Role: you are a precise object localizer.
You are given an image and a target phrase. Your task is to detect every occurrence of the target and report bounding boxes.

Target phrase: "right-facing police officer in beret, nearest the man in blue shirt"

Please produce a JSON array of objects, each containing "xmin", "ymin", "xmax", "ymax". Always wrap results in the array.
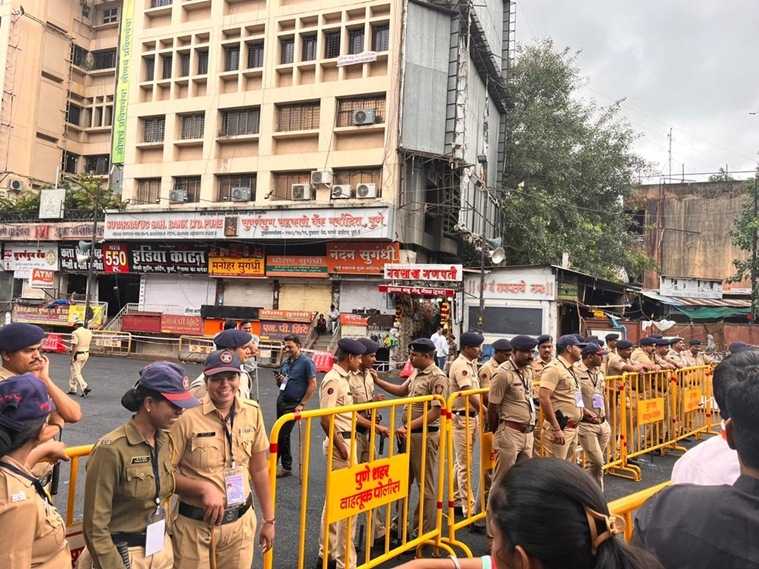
[{"xmin": 315, "ymin": 338, "xmax": 371, "ymax": 569}]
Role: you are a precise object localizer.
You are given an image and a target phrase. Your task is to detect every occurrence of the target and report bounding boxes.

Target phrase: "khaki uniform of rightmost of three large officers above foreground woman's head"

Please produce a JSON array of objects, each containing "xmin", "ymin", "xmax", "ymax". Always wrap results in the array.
[{"xmin": 575, "ymin": 362, "xmax": 611, "ymax": 491}]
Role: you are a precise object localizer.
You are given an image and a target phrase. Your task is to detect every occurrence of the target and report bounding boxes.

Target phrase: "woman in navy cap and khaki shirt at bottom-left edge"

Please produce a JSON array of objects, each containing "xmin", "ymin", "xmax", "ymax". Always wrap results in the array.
[{"xmin": 0, "ymin": 372, "xmax": 71, "ymax": 569}]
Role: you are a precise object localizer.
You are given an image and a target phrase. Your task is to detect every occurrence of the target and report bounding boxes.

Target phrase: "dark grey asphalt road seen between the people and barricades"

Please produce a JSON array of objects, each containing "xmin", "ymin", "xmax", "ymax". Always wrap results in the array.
[{"xmin": 44, "ymin": 354, "xmax": 704, "ymax": 569}]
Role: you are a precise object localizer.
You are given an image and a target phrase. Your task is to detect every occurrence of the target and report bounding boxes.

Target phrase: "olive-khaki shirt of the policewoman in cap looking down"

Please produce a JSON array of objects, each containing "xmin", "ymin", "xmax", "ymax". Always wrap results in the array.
[{"xmin": 83, "ymin": 418, "xmax": 174, "ymax": 567}]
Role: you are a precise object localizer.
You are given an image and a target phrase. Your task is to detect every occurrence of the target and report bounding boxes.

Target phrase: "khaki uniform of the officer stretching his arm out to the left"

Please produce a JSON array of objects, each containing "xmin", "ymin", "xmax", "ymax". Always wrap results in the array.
[{"xmin": 393, "ymin": 364, "xmax": 448, "ymax": 533}]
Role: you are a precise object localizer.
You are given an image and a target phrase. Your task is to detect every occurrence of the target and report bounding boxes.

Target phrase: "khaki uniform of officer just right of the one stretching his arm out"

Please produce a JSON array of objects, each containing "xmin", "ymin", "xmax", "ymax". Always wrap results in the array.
[{"xmin": 448, "ymin": 354, "xmax": 480, "ymax": 516}]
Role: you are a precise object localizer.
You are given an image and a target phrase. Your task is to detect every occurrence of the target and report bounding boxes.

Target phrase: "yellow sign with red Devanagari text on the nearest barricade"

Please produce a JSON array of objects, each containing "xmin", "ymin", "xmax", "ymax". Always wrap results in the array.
[{"xmin": 327, "ymin": 453, "xmax": 409, "ymax": 523}]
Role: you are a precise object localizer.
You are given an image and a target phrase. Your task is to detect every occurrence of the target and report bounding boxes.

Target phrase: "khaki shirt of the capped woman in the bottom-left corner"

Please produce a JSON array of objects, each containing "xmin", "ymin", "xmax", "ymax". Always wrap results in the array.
[{"xmin": 0, "ymin": 456, "xmax": 71, "ymax": 569}]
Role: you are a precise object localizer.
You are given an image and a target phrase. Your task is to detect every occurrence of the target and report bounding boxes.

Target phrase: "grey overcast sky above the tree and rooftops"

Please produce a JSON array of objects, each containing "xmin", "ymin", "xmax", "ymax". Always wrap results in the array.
[{"xmin": 517, "ymin": 0, "xmax": 759, "ymax": 182}]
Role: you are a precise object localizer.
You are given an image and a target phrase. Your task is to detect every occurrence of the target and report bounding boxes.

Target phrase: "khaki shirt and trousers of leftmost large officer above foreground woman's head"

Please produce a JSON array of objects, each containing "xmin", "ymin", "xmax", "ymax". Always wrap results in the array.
[{"xmin": 488, "ymin": 358, "xmax": 537, "ymax": 481}]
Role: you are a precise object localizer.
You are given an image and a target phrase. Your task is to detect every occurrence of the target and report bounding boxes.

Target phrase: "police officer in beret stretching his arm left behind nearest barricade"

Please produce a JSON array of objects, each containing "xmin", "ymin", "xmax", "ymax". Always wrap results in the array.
[{"xmin": 375, "ymin": 338, "xmax": 448, "ymax": 538}]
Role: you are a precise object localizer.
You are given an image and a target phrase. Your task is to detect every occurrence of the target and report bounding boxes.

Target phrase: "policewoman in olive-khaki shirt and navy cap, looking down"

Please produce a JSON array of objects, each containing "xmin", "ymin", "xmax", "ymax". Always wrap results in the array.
[{"xmin": 78, "ymin": 361, "xmax": 200, "ymax": 569}]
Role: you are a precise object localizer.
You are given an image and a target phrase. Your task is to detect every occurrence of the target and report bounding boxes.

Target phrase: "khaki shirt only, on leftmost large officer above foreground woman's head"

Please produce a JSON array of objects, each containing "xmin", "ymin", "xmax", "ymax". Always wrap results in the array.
[{"xmin": 488, "ymin": 359, "xmax": 535, "ymax": 425}]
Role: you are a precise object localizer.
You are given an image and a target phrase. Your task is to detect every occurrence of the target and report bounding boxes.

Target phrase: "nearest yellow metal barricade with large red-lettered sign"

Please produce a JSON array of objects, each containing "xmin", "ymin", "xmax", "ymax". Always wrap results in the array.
[{"xmin": 264, "ymin": 395, "xmax": 453, "ymax": 569}]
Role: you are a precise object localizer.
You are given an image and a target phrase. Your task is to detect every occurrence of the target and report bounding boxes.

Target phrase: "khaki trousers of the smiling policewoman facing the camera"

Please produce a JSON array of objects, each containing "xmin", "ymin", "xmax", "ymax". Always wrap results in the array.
[{"xmin": 172, "ymin": 508, "xmax": 257, "ymax": 569}]
